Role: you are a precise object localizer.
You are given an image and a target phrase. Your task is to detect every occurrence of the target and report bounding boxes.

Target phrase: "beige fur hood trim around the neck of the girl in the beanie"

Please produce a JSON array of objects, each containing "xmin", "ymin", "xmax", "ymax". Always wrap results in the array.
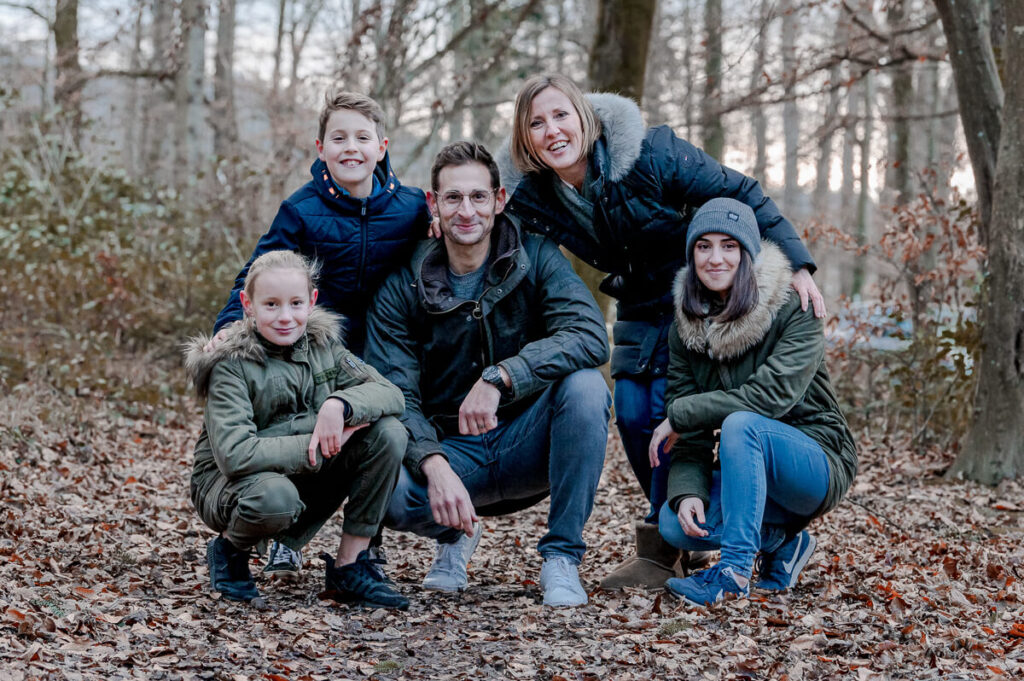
[{"xmin": 672, "ymin": 240, "xmax": 793, "ymax": 359}]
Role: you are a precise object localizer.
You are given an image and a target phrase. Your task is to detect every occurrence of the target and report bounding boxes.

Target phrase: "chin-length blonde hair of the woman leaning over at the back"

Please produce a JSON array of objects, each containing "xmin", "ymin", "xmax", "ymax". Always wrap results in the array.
[{"xmin": 509, "ymin": 74, "xmax": 601, "ymax": 173}]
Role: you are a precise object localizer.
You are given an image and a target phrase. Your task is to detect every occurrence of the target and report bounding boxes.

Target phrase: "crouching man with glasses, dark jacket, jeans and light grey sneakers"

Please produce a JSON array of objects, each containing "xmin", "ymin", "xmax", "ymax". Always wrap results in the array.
[{"xmin": 367, "ymin": 142, "xmax": 610, "ymax": 606}]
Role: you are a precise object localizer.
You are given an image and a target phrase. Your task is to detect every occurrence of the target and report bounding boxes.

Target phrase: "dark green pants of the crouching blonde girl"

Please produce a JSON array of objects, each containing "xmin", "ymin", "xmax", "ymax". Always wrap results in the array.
[{"xmin": 193, "ymin": 416, "xmax": 407, "ymax": 550}]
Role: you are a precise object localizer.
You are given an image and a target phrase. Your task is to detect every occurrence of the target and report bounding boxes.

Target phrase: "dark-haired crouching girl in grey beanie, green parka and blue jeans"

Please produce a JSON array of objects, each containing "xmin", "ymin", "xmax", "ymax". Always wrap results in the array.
[{"xmin": 648, "ymin": 199, "xmax": 857, "ymax": 605}]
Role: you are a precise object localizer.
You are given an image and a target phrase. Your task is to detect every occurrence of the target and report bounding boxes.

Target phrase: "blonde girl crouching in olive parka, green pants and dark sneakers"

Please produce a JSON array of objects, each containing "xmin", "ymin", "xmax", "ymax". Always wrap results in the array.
[{"xmin": 185, "ymin": 251, "xmax": 409, "ymax": 608}]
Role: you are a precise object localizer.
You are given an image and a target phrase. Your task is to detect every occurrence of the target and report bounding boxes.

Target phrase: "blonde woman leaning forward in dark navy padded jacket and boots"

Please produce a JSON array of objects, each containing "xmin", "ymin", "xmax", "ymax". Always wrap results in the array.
[{"xmin": 501, "ymin": 74, "xmax": 824, "ymax": 589}]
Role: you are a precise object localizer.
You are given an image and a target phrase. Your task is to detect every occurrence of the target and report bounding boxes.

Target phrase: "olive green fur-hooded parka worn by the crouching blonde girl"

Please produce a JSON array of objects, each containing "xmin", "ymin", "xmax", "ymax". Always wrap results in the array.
[{"xmin": 185, "ymin": 307, "xmax": 404, "ymax": 501}]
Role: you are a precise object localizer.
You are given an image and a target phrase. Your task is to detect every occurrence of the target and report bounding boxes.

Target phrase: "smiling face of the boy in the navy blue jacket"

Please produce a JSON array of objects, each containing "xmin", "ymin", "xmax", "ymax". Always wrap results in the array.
[{"xmin": 316, "ymin": 109, "xmax": 387, "ymax": 199}]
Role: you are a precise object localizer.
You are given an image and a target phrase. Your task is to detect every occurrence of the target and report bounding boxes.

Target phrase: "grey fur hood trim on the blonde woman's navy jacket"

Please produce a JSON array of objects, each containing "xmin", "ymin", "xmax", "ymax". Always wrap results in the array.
[{"xmin": 496, "ymin": 92, "xmax": 647, "ymax": 195}]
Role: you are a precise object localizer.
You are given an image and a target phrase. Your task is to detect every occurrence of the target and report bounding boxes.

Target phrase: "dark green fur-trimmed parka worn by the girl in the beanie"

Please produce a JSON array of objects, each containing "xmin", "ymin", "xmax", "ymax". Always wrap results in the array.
[{"xmin": 665, "ymin": 241, "xmax": 857, "ymax": 515}]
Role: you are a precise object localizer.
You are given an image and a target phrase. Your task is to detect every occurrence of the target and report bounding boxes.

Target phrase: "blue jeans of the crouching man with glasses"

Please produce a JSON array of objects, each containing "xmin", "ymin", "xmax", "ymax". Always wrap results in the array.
[{"xmin": 384, "ymin": 369, "xmax": 611, "ymax": 563}]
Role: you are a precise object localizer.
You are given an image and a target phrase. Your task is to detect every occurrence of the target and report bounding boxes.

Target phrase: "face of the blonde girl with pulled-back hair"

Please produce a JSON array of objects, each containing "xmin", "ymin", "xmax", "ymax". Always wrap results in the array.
[{"xmin": 240, "ymin": 268, "xmax": 316, "ymax": 345}]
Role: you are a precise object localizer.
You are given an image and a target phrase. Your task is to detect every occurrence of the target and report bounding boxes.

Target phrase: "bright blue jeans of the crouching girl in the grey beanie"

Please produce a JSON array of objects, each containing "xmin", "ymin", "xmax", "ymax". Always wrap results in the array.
[{"xmin": 658, "ymin": 412, "xmax": 828, "ymax": 577}]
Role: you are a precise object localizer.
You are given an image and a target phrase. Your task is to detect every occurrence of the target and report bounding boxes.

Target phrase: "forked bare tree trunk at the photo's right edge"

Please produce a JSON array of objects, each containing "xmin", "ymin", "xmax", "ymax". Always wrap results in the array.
[{"xmin": 935, "ymin": 0, "xmax": 1024, "ymax": 484}]
